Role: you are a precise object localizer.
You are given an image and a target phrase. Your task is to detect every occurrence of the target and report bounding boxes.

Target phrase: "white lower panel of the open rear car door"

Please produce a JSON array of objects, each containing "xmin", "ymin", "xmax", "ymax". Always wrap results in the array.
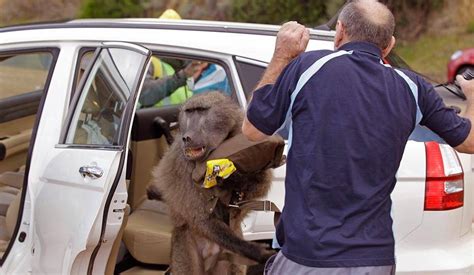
[{"xmin": 32, "ymin": 148, "xmax": 122, "ymax": 274}]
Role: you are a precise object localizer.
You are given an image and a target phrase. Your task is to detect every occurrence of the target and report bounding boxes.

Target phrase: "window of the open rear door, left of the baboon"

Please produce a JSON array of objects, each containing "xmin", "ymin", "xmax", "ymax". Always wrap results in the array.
[{"xmin": 64, "ymin": 48, "xmax": 145, "ymax": 146}]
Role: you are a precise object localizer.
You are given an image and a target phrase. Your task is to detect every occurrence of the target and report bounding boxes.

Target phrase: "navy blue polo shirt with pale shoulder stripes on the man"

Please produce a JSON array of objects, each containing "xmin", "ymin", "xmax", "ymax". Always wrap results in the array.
[{"xmin": 247, "ymin": 42, "xmax": 471, "ymax": 267}]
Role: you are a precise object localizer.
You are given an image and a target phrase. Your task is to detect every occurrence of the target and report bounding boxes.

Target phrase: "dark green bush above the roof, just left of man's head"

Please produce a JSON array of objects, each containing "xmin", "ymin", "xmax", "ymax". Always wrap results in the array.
[{"xmin": 232, "ymin": 0, "xmax": 329, "ymax": 26}]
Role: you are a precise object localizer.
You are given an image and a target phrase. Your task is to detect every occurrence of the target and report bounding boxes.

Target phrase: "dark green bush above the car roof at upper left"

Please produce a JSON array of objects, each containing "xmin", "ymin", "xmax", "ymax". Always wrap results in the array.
[{"xmin": 80, "ymin": 0, "xmax": 144, "ymax": 18}]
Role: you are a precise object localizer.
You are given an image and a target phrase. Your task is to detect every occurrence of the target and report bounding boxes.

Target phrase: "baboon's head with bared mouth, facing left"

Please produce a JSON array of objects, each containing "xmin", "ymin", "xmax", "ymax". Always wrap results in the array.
[{"xmin": 179, "ymin": 92, "xmax": 240, "ymax": 161}]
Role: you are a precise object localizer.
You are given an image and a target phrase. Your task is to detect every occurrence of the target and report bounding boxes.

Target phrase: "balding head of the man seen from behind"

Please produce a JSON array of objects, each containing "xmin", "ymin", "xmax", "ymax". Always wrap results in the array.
[{"xmin": 339, "ymin": 0, "xmax": 395, "ymax": 50}]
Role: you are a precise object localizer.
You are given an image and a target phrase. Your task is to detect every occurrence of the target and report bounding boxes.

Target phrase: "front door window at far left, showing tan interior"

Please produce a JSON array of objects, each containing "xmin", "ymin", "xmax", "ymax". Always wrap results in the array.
[{"xmin": 0, "ymin": 50, "xmax": 55, "ymax": 164}]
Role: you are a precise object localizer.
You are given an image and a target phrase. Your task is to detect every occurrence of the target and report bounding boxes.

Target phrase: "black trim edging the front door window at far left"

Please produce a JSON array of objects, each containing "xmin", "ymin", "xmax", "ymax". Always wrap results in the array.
[{"xmin": 0, "ymin": 46, "xmax": 60, "ymax": 266}]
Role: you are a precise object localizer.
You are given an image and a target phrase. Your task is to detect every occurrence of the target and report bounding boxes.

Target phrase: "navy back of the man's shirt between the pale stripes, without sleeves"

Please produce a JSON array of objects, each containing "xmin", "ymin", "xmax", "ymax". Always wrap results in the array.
[{"xmin": 274, "ymin": 43, "xmax": 416, "ymax": 267}]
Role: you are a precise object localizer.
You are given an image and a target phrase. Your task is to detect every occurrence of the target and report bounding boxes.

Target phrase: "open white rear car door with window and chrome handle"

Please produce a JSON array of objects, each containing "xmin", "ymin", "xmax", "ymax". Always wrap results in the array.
[{"xmin": 4, "ymin": 42, "xmax": 151, "ymax": 274}]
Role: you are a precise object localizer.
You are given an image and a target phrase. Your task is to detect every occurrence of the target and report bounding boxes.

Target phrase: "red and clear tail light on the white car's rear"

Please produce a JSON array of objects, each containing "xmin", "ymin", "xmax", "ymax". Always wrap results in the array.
[{"xmin": 425, "ymin": 142, "xmax": 464, "ymax": 211}]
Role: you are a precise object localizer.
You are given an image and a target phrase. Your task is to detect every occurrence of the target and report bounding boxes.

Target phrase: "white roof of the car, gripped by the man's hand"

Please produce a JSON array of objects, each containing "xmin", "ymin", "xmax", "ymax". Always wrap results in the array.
[{"xmin": 0, "ymin": 18, "xmax": 334, "ymax": 62}]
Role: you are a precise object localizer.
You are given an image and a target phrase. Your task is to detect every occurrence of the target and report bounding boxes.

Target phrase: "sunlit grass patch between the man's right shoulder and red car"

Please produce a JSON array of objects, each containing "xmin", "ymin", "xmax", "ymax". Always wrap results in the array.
[{"xmin": 396, "ymin": 32, "xmax": 474, "ymax": 82}]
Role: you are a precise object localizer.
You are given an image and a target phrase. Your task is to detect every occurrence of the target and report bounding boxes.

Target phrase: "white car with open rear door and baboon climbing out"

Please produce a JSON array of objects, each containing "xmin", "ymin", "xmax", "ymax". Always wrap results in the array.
[{"xmin": 0, "ymin": 19, "xmax": 474, "ymax": 274}]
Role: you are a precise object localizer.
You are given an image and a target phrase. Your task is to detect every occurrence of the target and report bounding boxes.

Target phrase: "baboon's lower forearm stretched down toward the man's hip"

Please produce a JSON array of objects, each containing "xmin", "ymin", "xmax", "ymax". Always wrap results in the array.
[{"xmin": 192, "ymin": 217, "xmax": 273, "ymax": 263}]
